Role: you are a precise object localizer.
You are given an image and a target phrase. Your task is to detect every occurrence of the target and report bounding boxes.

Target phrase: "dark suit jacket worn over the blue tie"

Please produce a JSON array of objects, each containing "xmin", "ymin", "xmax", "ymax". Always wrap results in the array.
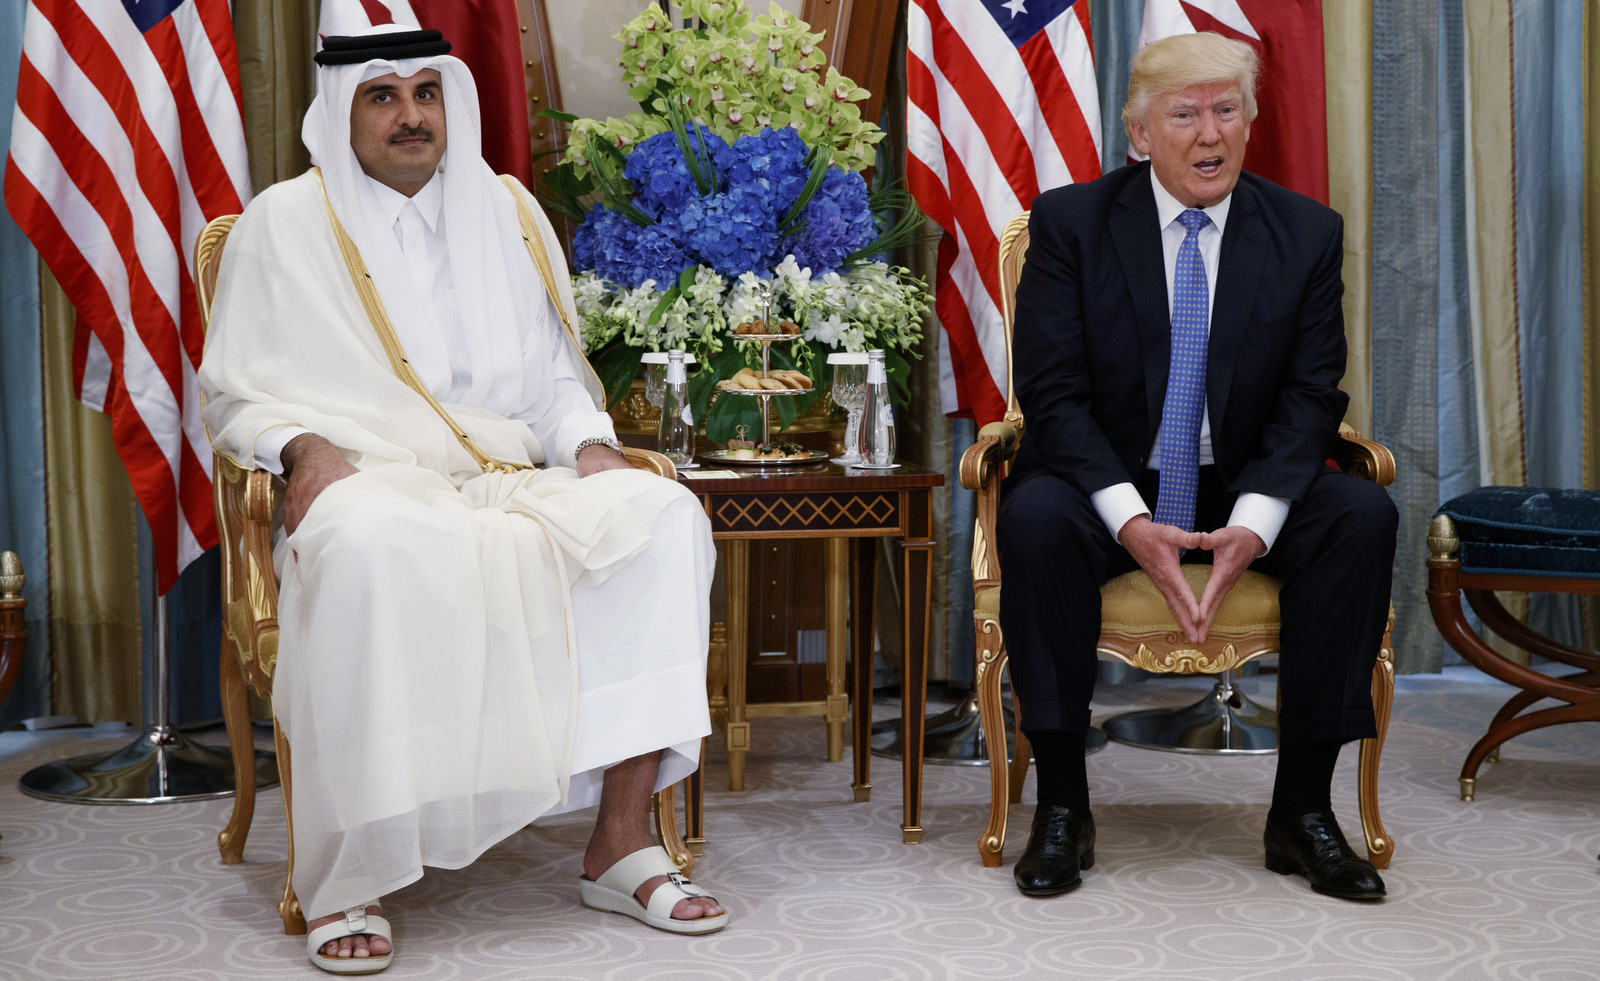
[{"xmin": 1011, "ymin": 163, "xmax": 1349, "ymax": 501}]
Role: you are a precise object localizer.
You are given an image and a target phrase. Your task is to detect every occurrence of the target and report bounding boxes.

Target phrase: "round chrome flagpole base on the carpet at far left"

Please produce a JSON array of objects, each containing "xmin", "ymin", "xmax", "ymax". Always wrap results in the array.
[{"xmin": 18, "ymin": 725, "xmax": 278, "ymax": 803}]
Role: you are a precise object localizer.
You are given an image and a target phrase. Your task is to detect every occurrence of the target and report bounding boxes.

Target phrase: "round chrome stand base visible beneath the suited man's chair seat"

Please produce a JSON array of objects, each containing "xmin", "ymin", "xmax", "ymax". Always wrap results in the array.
[{"xmin": 1101, "ymin": 677, "xmax": 1278, "ymax": 755}]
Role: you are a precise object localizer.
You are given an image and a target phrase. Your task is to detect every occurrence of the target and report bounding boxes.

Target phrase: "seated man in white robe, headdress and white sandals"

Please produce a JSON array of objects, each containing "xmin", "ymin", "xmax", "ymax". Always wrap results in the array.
[{"xmin": 198, "ymin": 26, "xmax": 726, "ymax": 971}]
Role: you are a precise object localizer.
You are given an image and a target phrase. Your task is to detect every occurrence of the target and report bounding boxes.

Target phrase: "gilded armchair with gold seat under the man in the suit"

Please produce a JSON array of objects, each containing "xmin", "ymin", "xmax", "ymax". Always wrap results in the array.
[{"xmin": 960, "ymin": 211, "xmax": 1395, "ymax": 869}]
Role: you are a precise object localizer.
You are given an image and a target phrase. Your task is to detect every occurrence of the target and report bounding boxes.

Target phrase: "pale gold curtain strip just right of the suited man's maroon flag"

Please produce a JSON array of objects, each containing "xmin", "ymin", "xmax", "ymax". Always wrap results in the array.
[{"xmin": 1322, "ymin": 3, "xmax": 1373, "ymax": 434}]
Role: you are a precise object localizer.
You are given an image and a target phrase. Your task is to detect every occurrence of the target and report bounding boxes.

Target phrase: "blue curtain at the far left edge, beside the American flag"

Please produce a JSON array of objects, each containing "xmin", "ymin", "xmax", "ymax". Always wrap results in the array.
[{"xmin": 0, "ymin": 3, "xmax": 50, "ymax": 728}]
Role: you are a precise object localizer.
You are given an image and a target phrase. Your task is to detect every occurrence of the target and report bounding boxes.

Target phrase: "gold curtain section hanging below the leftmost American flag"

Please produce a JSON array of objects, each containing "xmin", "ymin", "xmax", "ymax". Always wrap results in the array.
[{"xmin": 38, "ymin": 262, "xmax": 141, "ymax": 723}]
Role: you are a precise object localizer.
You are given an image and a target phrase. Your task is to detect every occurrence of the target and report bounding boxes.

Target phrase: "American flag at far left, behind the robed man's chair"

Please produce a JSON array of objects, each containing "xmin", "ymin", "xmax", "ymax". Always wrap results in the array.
[{"xmin": 5, "ymin": 0, "xmax": 250, "ymax": 592}]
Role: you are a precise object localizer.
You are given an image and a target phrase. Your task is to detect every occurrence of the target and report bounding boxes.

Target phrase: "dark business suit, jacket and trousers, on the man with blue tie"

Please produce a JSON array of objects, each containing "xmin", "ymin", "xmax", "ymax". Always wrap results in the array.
[{"xmin": 997, "ymin": 163, "xmax": 1397, "ymax": 746}]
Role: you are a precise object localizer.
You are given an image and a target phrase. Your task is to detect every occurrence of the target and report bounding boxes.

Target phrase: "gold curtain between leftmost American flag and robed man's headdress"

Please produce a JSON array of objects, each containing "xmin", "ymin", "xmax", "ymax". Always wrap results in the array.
[{"xmin": 234, "ymin": 0, "xmax": 322, "ymax": 192}]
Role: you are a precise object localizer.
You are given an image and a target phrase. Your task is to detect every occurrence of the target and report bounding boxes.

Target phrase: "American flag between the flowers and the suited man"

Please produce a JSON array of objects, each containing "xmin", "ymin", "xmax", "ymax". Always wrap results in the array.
[{"xmin": 906, "ymin": 0, "xmax": 1101, "ymax": 426}]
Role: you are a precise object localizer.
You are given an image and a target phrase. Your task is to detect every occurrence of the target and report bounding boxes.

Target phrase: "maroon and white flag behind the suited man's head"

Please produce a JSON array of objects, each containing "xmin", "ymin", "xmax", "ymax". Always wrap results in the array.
[{"xmin": 1139, "ymin": 0, "xmax": 1328, "ymax": 205}]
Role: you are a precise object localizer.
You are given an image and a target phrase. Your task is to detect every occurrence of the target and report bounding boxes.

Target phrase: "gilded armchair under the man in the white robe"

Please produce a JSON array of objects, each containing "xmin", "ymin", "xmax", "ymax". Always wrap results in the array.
[{"xmin": 194, "ymin": 214, "xmax": 694, "ymax": 935}]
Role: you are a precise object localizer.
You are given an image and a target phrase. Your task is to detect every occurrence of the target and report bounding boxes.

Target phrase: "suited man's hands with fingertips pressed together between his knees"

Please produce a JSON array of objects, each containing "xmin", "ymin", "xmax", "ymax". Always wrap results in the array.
[{"xmin": 1117, "ymin": 514, "xmax": 1266, "ymax": 643}]
